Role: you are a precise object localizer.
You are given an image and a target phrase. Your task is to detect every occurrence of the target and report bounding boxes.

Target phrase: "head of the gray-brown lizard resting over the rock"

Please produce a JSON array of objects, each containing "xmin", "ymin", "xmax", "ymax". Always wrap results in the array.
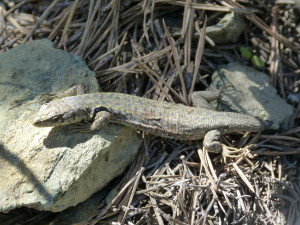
[{"xmin": 33, "ymin": 100, "xmax": 89, "ymax": 127}]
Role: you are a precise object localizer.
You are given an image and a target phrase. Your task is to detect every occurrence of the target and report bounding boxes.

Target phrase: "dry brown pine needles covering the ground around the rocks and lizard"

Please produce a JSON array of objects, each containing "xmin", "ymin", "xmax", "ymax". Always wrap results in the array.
[{"xmin": 0, "ymin": 0, "xmax": 300, "ymax": 225}]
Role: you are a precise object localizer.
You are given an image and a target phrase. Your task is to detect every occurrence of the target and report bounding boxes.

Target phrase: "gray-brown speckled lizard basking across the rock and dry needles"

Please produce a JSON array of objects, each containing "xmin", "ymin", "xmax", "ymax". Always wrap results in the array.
[{"xmin": 33, "ymin": 92, "xmax": 270, "ymax": 152}]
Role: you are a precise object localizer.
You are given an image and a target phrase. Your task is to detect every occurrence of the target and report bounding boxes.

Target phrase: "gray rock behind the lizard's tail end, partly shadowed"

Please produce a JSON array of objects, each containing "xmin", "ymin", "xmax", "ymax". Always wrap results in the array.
[{"xmin": 212, "ymin": 63, "xmax": 294, "ymax": 129}]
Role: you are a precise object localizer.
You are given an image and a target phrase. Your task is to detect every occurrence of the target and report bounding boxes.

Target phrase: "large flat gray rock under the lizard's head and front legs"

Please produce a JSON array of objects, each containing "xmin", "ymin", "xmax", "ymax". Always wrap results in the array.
[{"xmin": 0, "ymin": 40, "xmax": 141, "ymax": 212}]
